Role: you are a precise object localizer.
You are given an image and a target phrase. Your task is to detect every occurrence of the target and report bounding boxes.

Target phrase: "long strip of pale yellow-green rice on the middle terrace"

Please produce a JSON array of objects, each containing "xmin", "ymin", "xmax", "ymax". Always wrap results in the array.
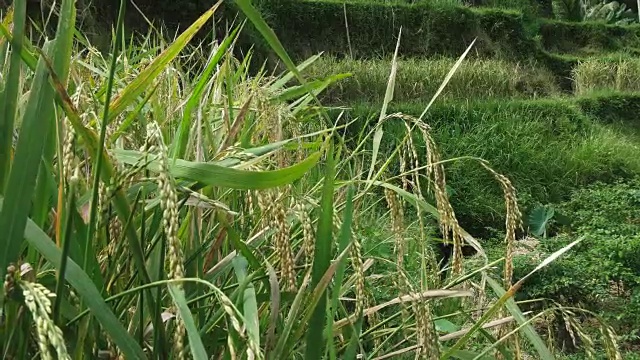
[{"xmin": 305, "ymin": 57, "xmax": 559, "ymax": 104}]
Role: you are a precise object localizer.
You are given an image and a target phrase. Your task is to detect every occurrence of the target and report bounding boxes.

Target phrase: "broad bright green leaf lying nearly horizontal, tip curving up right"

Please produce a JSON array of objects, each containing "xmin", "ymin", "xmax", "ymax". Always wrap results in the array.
[{"xmin": 113, "ymin": 150, "xmax": 320, "ymax": 189}]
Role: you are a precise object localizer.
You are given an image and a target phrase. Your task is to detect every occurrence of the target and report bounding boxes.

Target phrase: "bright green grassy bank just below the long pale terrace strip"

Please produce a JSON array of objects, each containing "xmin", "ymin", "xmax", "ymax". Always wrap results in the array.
[{"xmin": 336, "ymin": 97, "xmax": 640, "ymax": 234}]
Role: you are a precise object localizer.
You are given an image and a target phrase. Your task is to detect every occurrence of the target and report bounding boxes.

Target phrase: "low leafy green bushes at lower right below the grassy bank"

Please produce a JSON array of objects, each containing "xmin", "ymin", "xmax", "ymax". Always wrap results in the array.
[{"xmin": 514, "ymin": 177, "xmax": 640, "ymax": 347}]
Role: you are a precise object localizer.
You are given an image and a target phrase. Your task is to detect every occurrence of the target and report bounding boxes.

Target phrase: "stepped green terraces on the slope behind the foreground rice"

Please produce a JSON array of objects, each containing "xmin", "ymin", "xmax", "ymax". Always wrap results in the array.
[{"xmin": 236, "ymin": 0, "xmax": 640, "ymax": 231}]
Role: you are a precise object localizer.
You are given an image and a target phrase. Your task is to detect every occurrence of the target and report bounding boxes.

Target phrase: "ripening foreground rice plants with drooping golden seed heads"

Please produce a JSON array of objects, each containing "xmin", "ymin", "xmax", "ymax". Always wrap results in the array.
[{"xmin": 0, "ymin": 0, "xmax": 610, "ymax": 359}]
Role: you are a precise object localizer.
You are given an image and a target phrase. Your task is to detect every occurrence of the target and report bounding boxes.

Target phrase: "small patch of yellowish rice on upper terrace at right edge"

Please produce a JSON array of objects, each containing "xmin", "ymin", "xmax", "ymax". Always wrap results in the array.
[{"xmin": 573, "ymin": 57, "xmax": 640, "ymax": 95}]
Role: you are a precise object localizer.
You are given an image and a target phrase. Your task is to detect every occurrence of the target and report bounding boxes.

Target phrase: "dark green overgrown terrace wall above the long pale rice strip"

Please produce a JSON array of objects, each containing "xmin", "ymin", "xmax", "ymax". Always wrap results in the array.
[{"xmin": 248, "ymin": 0, "xmax": 535, "ymax": 59}]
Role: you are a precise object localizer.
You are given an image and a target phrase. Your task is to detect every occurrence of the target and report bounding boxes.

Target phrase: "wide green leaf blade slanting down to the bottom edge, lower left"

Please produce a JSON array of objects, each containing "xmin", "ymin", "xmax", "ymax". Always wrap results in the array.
[{"xmin": 0, "ymin": 198, "xmax": 147, "ymax": 359}]
